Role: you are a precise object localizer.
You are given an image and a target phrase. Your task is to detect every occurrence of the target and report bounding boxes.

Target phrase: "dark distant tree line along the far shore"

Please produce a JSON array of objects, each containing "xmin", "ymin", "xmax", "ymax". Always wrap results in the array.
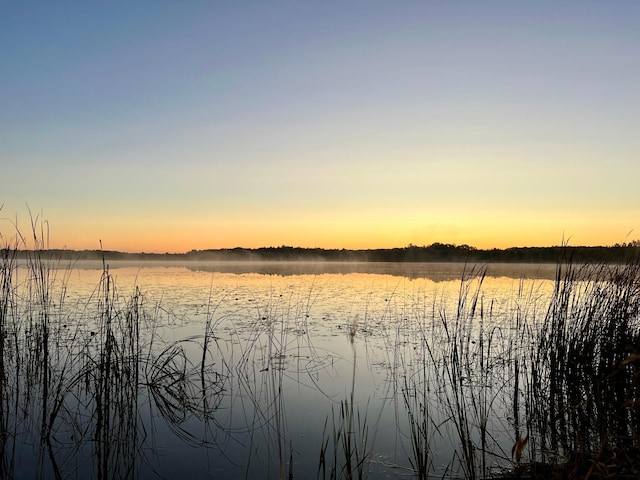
[{"xmin": 5, "ymin": 240, "xmax": 640, "ymax": 263}]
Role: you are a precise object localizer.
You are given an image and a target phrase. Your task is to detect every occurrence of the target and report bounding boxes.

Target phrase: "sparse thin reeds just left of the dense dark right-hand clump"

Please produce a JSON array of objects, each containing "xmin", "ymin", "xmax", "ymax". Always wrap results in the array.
[{"xmin": 433, "ymin": 267, "xmax": 516, "ymax": 478}]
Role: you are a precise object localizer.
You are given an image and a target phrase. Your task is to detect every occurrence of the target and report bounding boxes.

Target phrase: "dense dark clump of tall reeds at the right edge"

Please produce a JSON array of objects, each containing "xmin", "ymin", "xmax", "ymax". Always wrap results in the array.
[{"xmin": 527, "ymin": 258, "xmax": 640, "ymax": 478}]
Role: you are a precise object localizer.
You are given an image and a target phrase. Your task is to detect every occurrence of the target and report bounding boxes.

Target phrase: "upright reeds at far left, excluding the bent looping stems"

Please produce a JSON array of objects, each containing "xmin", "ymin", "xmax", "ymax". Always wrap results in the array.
[{"xmin": 2, "ymin": 249, "xmax": 148, "ymax": 478}]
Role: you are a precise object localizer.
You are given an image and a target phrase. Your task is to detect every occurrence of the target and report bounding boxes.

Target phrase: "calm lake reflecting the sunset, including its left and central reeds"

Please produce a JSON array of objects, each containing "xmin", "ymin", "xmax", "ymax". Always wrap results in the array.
[{"xmin": 0, "ymin": 262, "xmax": 620, "ymax": 479}]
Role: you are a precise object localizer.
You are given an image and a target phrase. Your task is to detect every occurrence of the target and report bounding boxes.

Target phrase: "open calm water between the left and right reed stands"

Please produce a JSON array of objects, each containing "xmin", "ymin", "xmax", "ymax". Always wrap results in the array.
[{"xmin": 12, "ymin": 262, "xmax": 555, "ymax": 479}]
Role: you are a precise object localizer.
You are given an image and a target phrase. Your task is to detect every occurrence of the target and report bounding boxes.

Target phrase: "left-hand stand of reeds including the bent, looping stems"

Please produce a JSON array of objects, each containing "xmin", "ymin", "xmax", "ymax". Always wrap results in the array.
[{"xmin": 0, "ymin": 219, "xmax": 226, "ymax": 479}]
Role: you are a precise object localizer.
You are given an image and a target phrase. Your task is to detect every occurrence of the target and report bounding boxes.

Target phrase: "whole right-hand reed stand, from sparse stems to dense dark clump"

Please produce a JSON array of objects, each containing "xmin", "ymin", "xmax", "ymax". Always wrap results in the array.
[{"xmin": 396, "ymin": 253, "xmax": 640, "ymax": 478}]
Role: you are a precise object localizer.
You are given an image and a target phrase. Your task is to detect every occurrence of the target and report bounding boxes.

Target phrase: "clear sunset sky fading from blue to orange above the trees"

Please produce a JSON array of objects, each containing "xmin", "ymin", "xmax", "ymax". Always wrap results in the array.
[{"xmin": 0, "ymin": 0, "xmax": 640, "ymax": 253}]
